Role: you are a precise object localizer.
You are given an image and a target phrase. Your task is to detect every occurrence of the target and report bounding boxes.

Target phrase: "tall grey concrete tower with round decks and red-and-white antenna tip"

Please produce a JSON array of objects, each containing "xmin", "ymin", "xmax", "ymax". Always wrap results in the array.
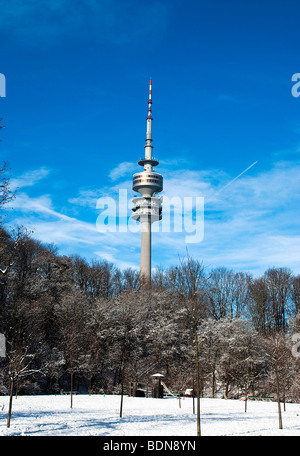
[{"xmin": 132, "ymin": 79, "xmax": 163, "ymax": 285}]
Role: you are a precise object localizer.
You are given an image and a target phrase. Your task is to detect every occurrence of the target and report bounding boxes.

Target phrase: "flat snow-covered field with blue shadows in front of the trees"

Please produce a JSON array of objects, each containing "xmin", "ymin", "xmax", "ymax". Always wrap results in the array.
[{"xmin": 0, "ymin": 395, "xmax": 300, "ymax": 436}]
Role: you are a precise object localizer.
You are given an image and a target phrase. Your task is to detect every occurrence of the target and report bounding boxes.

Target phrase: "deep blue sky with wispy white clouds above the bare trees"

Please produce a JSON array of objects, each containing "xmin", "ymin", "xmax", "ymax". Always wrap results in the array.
[{"xmin": 0, "ymin": 0, "xmax": 300, "ymax": 275}]
